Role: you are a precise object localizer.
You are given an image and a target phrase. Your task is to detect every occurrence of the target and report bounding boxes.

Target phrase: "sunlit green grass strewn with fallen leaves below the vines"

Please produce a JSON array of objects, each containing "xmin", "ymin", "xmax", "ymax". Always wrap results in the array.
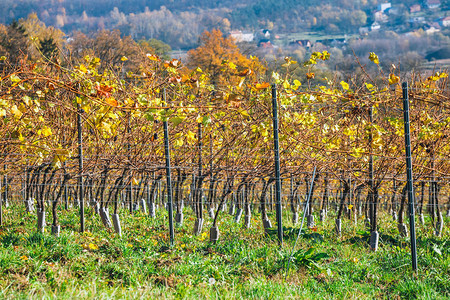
[{"xmin": 0, "ymin": 207, "xmax": 450, "ymax": 299}]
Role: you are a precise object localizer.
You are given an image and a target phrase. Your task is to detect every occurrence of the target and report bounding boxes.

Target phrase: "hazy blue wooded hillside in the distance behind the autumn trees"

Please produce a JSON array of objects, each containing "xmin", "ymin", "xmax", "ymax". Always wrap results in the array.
[{"xmin": 0, "ymin": 0, "xmax": 450, "ymax": 49}]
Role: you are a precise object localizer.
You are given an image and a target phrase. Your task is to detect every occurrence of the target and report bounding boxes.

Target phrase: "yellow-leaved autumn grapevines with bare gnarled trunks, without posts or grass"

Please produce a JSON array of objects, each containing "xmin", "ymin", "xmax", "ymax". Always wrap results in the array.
[{"xmin": 0, "ymin": 51, "xmax": 450, "ymax": 247}]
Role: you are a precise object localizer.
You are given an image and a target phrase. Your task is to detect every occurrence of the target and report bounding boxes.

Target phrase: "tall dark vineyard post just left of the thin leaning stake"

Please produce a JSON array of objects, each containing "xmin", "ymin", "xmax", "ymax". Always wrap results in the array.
[{"xmin": 272, "ymin": 84, "xmax": 283, "ymax": 247}]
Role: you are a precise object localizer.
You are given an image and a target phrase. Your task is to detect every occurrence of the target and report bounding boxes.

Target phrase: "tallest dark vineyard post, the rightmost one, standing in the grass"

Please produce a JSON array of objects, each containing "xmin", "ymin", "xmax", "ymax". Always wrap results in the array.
[{"xmin": 402, "ymin": 82, "xmax": 417, "ymax": 271}]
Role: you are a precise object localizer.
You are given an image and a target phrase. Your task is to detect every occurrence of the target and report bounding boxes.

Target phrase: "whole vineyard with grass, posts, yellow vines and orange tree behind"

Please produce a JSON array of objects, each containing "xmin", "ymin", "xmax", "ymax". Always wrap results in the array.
[{"xmin": 0, "ymin": 27, "xmax": 450, "ymax": 299}]
